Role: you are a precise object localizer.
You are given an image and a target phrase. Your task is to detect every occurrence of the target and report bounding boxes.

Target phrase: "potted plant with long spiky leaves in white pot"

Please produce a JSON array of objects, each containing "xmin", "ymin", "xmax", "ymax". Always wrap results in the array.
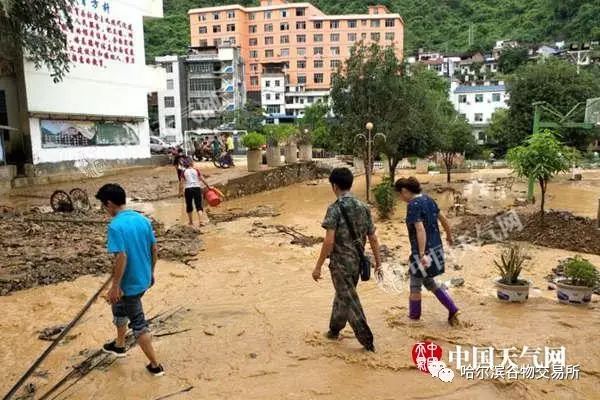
[{"xmin": 494, "ymin": 245, "xmax": 530, "ymax": 302}]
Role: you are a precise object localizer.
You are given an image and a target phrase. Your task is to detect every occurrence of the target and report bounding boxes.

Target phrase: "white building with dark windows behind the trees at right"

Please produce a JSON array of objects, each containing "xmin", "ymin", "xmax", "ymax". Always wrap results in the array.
[{"xmin": 450, "ymin": 81, "xmax": 508, "ymax": 144}]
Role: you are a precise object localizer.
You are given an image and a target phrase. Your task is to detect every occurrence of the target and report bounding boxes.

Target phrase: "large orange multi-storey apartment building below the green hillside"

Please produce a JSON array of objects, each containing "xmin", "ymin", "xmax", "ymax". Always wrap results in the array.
[{"xmin": 188, "ymin": 0, "xmax": 404, "ymax": 117}]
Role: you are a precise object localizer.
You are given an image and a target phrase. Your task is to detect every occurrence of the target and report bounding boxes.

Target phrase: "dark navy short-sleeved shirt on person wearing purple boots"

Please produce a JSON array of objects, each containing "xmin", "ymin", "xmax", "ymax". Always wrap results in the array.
[{"xmin": 406, "ymin": 194, "xmax": 442, "ymax": 257}]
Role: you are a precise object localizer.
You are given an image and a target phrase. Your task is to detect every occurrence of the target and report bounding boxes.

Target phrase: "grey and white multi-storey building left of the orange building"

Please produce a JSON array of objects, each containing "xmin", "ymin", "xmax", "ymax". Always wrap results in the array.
[{"xmin": 156, "ymin": 44, "xmax": 246, "ymax": 142}]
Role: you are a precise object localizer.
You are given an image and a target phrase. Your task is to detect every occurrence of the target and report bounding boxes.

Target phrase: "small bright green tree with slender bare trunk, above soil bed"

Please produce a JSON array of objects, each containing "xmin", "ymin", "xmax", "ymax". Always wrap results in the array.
[{"xmin": 507, "ymin": 130, "xmax": 577, "ymax": 222}]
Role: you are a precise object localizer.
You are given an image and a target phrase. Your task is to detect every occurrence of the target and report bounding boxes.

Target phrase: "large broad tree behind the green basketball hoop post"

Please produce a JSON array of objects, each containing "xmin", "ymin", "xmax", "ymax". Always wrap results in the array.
[{"xmin": 498, "ymin": 60, "xmax": 600, "ymax": 149}]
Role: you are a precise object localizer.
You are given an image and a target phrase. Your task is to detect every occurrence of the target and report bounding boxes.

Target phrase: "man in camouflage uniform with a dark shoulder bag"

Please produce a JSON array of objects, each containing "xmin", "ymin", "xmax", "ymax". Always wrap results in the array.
[{"xmin": 312, "ymin": 168, "xmax": 381, "ymax": 351}]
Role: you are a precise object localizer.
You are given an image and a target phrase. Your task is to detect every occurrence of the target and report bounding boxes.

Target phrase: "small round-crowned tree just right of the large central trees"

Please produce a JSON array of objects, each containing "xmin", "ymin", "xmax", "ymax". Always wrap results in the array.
[{"xmin": 439, "ymin": 114, "xmax": 475, "ymax": 183}]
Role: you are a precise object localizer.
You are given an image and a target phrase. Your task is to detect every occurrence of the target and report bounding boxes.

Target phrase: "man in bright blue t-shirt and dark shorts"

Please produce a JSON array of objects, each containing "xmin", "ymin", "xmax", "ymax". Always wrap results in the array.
[{"xmin": 96, "ymin": 184, "xmax": 164, "ymax": 376}]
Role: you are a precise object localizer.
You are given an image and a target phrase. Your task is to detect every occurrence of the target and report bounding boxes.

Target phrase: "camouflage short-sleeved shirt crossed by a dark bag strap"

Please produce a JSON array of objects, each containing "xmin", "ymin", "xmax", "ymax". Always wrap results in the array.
[{"xmin": 321, "ymin": 193, "xmax": 375, "ymax": 272}]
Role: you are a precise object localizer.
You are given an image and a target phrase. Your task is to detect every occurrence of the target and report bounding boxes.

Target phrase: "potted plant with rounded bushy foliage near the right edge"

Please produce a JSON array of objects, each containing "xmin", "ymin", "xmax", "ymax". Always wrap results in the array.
[{"xmin": 556, "ymin": 256, "xmax": 599, "ymax": 304}]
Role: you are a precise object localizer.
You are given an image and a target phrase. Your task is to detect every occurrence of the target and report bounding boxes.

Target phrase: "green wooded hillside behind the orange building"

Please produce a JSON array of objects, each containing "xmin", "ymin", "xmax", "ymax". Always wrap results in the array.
[{"xmin": 145, "ymin": 0, "xmax": 600, "ymax": 60}]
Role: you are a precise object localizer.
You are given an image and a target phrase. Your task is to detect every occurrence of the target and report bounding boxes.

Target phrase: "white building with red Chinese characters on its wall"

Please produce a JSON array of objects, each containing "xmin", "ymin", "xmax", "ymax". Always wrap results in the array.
[{"xmin": 0, "ymin": 0, "xmax": 164, "ymax": 188}]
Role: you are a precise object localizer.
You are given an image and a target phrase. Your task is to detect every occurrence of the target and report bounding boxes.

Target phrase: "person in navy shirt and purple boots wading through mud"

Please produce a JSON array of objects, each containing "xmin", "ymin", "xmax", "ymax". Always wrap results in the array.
[{"xmin": 395, "ymin": 177, "xmax": 458, "ymax": 326}]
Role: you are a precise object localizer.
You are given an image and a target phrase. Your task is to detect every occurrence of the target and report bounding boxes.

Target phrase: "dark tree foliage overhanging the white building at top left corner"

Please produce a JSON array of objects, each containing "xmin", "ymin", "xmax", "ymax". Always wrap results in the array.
[{"xmin": 0, "ymin": 0, "xmax": 73, "ymax": 82}]
